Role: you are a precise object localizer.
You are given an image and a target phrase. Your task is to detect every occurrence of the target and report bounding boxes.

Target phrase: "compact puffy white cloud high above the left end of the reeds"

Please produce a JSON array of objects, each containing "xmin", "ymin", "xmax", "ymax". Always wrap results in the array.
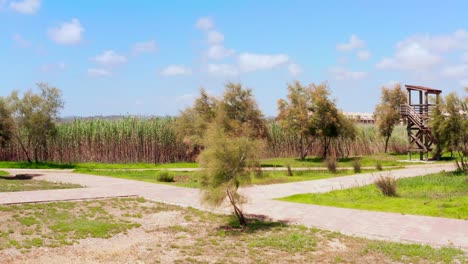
[{"xmin": 48, "ymin": 18, "xmax": 84, "ymax": 44}]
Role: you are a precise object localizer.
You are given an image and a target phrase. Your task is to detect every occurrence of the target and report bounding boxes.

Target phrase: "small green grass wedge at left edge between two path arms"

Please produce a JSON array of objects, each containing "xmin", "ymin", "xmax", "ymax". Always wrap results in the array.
[{"xmin": 0, "ymin": 171, "xmax": 83, "ymax": 192}]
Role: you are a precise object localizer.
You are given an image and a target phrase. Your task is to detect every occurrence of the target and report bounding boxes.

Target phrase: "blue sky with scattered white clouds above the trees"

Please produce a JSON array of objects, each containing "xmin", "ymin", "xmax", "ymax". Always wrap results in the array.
[{"xmin": 0, "ymin": 0, "xmax": 468, "ymax": 116}]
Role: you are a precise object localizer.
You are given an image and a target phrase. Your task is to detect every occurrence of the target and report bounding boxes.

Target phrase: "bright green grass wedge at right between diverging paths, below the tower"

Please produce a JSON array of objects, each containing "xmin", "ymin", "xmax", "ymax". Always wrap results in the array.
[{"xmin": 280, "ymin": 173, "xmax": 468, "ymax": 219}]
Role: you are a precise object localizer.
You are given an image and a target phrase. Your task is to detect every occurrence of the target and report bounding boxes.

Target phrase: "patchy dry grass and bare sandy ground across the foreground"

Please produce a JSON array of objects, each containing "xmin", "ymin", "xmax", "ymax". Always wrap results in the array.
[{"xmin": 0, "ymin": 198, "xmax": 466, "ymax": 263}]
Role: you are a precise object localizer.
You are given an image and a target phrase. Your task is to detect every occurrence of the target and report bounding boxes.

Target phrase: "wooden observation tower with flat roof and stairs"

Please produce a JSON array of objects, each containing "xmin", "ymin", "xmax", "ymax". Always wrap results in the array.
[{"xmin": 400, "ymin": 85, "xmax": 442, "ymax": 160}]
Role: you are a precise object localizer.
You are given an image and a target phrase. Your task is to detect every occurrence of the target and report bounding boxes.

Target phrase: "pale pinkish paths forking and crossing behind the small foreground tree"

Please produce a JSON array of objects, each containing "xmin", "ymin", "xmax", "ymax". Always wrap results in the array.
[{"xmin": 0, "ymin": 164, "xmax": 468, "ymax": 250}]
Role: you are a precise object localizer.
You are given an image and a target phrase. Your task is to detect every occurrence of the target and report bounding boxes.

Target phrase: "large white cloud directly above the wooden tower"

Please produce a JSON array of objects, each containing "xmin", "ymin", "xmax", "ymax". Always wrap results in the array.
[{"xmin": 376, "ymin": 43, "xmax": 442, "ymax": 70}]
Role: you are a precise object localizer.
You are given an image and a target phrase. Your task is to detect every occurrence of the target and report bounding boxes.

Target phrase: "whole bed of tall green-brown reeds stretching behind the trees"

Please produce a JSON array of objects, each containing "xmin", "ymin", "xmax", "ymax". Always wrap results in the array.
[{"xmin": 0, "ymin": 117, "xmax": 407, "ymax": 163}]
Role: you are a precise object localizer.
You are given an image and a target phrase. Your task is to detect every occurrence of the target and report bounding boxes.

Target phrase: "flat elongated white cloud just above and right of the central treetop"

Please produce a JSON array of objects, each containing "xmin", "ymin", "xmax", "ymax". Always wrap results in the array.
[{"xmin": 239, "ymin": 53, "xmax": 289, "ymax": 72}]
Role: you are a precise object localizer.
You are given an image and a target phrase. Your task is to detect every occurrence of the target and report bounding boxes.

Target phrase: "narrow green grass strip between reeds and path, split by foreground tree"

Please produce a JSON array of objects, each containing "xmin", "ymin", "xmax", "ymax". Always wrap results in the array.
[{"xmin": 75, "ymin": 169, "xmax": 376, "ymax": 188}]
